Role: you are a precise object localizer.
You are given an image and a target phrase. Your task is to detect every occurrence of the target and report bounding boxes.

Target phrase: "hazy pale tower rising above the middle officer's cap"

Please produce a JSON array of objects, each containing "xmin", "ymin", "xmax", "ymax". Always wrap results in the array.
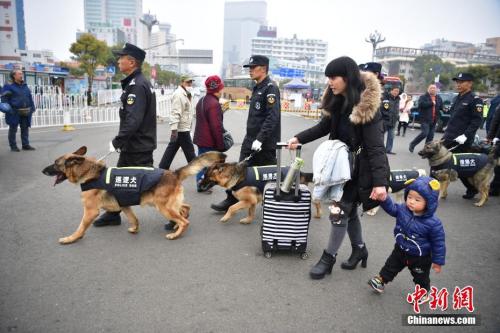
[{"xmin": 222, "ymin": 1, "xmax": 267, "ymax": 75}]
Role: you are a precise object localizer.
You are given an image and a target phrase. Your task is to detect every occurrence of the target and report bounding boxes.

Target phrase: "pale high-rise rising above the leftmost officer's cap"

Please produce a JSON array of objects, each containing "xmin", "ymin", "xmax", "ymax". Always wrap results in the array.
[{"xmin": 84, "ymin": 0, "xmax": 142, "ymax": 44}]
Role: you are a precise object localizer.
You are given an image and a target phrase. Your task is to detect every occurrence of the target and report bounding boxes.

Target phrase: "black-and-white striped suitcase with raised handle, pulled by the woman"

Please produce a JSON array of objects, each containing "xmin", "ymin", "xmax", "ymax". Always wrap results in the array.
[{"xmin": 261, "ymin": 143, "xmax": 311, "ymax": 259}]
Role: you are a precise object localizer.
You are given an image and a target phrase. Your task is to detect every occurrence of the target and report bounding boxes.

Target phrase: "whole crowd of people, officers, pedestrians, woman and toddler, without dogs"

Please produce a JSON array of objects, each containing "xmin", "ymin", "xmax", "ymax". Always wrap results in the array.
[{"xmin": 2, "ymin": 43, "xmax": 500, "ymax": 292}]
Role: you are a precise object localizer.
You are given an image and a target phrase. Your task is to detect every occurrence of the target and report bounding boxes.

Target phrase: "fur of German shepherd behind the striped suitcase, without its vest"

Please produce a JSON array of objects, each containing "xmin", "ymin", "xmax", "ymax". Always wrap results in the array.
[{"xmin": 200, "ymin": 162, "xmax": 321, "ymax": 224}]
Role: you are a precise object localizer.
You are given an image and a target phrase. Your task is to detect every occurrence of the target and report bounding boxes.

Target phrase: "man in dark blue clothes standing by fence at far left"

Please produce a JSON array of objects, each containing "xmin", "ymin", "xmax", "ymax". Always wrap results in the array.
[{"xmin": 1, "ymin": 69, "xmax": 36, "ymax": 152}]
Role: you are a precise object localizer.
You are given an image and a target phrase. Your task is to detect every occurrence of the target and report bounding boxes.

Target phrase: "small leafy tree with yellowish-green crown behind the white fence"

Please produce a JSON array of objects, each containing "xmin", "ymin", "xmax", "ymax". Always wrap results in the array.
[{"xmin": 69, "ymin": 34, "xmax": 109, "ymax": 105}]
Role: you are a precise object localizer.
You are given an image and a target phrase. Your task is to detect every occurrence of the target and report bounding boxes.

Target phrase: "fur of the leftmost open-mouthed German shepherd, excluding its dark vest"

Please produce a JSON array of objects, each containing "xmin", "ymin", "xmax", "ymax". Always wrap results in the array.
[{"xmin": 42, "ymin": 146, "xmax": 226, "ymax": 244}]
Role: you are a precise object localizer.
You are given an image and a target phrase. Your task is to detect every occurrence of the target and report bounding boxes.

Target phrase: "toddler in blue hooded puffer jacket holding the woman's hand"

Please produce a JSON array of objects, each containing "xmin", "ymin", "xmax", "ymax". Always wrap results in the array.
[{"xmin": 368, "ymin": 177, "xmax": 446, "ymax": 295}]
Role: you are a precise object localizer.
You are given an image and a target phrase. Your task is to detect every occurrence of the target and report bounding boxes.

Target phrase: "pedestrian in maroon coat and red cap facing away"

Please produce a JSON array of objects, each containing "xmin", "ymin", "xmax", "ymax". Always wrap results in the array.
[{"xmin": 193, "ymin": 75, "xmax": 224, "ymax": 189}]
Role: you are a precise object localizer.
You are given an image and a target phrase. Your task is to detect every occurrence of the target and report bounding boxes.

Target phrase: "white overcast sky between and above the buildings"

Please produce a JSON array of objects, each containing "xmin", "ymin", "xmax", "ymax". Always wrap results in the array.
[{"xmin": 24, "ymin": 0, "xmax": 500, "ymax": 74}]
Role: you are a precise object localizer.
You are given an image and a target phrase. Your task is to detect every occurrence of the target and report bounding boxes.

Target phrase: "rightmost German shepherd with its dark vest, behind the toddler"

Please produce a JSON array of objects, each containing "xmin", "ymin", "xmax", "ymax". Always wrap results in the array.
[{"xmin": 418, "ymin": 140, "xmax": 500, "ymax": 207}]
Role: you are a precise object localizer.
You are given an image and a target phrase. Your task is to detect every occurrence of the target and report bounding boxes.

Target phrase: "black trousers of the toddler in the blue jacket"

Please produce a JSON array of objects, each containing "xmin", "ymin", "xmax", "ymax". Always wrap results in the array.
[{"xmin": 379, "ymin": 244, "xmax": 432, "ymax": 291}]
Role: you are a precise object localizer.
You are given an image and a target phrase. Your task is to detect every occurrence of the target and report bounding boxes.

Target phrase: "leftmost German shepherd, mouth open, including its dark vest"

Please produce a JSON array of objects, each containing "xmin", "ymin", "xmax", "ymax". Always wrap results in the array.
[{"xmin": 42, "ymin": 146, "xmax": 226, "ymax": 244}]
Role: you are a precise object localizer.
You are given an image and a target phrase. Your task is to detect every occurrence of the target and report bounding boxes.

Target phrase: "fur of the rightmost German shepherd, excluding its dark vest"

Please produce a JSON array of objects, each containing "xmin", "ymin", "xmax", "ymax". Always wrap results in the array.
[{"xmin": 418, "ymin": 141, "xmax": 500, "ymax": 207}]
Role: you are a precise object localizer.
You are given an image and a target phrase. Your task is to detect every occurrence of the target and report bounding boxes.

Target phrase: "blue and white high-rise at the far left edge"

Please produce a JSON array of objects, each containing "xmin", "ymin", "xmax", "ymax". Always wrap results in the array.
[{"xmin": 0, "ymin": 0, "xmax": 26, "ymax": 64}]
